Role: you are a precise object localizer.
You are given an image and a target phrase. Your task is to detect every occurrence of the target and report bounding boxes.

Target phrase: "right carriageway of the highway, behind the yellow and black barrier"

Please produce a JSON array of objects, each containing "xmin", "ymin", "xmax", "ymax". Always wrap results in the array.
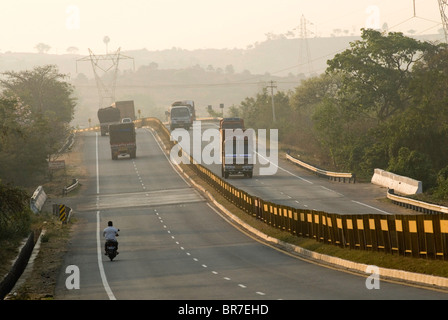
[{"xmin": 184, "ymin": 122, "xmax": 416, "ymax": 214}]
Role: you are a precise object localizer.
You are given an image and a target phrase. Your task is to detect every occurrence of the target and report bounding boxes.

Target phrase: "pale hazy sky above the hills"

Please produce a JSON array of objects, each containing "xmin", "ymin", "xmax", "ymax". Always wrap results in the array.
[{"xmin": 0, "ymin": 0, "xmax": 442, "ymax": 54}]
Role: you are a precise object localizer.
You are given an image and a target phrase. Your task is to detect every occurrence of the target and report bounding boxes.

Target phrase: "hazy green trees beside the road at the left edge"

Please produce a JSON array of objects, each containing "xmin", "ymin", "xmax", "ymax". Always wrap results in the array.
[{"xmin": 0, "ymin": 66, "xmax": 75, "ymax": 240}]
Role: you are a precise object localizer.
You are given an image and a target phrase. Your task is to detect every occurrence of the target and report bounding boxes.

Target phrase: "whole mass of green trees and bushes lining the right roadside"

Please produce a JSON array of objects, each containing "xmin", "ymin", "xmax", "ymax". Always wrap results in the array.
[{"xmin": 232, "ymin": 30, "xmax": 448, "ymax": 198}]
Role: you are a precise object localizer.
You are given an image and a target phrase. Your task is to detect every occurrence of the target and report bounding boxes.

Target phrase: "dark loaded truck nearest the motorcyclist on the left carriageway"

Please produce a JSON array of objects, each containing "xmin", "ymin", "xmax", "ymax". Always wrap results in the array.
[{"xmin": 109, "ymin": 122, "xmax": 137, "ymax": 160}]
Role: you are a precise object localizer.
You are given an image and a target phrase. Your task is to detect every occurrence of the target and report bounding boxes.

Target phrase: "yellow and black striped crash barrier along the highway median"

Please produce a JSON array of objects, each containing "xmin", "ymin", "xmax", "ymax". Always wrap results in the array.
[{"xmin": 143, "ymin": 118, "xmax": 448, "ymax": 260}]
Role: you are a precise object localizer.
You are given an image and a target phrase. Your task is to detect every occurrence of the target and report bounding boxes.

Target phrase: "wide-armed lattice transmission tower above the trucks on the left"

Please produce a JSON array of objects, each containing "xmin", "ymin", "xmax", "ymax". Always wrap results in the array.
[{"xmin": 76, "ymin": 48, "xmax": 135, "ymax": 108}]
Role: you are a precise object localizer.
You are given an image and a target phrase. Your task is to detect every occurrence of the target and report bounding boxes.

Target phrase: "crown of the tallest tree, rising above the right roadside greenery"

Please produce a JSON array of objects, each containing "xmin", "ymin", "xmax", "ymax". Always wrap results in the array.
[{"xmin": 327, "ymin": 29, "xmax": 432, "ymax": 121}]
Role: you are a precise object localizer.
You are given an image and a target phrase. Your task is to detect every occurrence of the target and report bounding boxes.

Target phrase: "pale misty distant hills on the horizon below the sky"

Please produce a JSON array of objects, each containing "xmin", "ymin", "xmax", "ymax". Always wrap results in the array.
[{"xmin": 0, "ymin": 35, "xmax": 440, "ymax": 126}]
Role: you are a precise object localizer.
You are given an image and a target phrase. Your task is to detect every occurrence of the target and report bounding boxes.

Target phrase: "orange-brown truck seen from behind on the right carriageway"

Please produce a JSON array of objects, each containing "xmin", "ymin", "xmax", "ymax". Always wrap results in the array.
[{"xmin": 219, "ymin": 118, "xmax": 254, "ymax": 179}]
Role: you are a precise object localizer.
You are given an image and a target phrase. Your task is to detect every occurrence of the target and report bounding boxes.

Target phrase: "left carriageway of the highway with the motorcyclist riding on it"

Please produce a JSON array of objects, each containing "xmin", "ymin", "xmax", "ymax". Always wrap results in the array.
[{"xmin": 55, "ymin": 128, "xmax": 448, "ymax": 300}]
